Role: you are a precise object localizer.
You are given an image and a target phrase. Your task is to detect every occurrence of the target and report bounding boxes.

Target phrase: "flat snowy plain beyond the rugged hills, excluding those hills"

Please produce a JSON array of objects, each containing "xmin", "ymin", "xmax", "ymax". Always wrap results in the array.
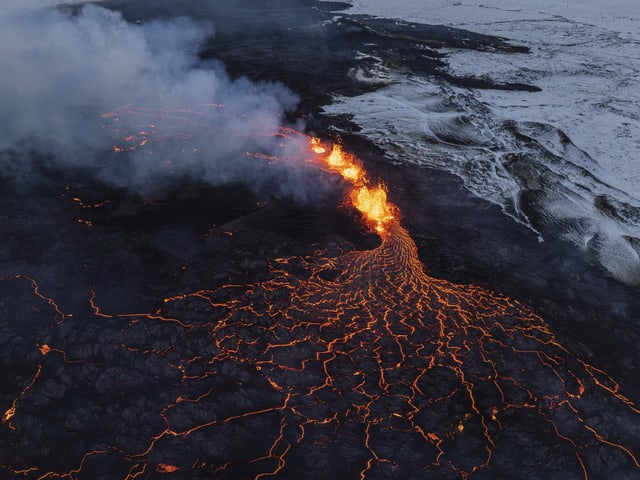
[{"xmin": 344, "ymin": 0, "xmax": 640, "ymax": 197}]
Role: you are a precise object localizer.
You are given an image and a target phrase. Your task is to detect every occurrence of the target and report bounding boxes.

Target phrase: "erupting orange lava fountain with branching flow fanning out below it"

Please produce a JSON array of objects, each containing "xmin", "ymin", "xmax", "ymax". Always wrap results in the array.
[{"xmin": 0, "ymin": 113, "xmax": 640, "ymax": 480}]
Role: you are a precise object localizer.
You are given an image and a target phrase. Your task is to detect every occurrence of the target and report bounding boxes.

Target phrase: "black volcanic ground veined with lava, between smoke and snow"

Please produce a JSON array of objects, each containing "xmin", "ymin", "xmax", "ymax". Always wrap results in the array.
[{"xmin": 0, "ymin": 1, "xmax": 640, "ymax": 479}]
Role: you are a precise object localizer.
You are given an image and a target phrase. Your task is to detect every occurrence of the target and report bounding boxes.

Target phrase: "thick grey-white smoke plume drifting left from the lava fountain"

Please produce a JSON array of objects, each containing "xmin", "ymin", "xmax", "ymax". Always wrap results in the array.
[{"xmin": 0, "ymin": 2, "xmax": 316, "ymax": 198}]
